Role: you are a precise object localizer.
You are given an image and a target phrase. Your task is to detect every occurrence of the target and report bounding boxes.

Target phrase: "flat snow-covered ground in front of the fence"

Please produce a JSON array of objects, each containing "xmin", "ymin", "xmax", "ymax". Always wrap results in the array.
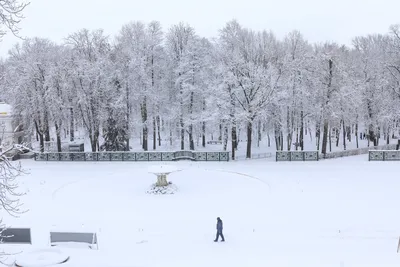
[{"xmin": 0, "ymin": 155, "xmax": 400, "ymax": 267}]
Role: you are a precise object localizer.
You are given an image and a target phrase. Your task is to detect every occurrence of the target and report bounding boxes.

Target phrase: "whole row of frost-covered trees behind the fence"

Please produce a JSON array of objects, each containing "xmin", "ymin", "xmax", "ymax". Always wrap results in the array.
[{"xmin": 1, "ymin": 21, "xmax": 400, "ymax": 158}]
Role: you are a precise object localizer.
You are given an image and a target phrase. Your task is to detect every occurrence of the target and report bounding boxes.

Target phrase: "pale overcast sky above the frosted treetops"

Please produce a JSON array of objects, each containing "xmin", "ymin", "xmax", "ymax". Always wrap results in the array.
[{"xmin": 0, "ymin": 0, "xmax": 400, "ymax": 57}]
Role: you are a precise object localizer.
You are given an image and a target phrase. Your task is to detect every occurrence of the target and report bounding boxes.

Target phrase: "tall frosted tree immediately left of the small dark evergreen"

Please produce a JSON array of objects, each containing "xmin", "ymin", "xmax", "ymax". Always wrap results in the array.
[{"xmin": 66, "ymin": 29, "xmax": 111, "ymax": 152}]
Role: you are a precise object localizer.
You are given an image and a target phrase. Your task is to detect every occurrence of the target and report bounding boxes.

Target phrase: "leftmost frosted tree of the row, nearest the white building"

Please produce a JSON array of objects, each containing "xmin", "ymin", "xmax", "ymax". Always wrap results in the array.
[{"xmin": 5, "ymin": 38, "xmax": 56, "ymax": 151}]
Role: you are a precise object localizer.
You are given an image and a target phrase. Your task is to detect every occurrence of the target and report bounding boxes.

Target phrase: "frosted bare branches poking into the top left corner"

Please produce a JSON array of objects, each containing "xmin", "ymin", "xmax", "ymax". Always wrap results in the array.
[{"xmin": 0, "ymin": 0, "xmax": 29, "ymax": 39}]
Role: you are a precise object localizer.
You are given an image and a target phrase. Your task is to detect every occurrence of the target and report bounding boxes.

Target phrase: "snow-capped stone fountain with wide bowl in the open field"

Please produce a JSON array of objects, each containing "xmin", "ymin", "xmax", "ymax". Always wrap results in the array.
[{"xmin": 147, "ymin": 165, "xmax": 181, "ymax": 195}]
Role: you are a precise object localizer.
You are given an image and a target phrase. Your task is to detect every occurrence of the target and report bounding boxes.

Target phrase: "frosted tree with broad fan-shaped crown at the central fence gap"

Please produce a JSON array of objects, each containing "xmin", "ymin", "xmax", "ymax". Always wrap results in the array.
[{"xmin": 220, "ymin": 21, "xmax": 282, "ymax": 158}]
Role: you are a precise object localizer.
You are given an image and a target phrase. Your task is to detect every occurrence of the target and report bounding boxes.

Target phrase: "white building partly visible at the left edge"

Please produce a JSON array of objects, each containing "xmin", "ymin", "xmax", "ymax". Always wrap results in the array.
[{"xmin": 0, "ymin": 100, "xmax": 25, "ymax": 151}]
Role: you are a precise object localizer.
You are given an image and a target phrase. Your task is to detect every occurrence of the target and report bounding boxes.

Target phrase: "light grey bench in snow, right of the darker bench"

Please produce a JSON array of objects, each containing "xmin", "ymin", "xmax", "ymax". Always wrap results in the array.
[{"xmin": 50, "ymin": 232, "xmax": 99, "ymax": 249}]
